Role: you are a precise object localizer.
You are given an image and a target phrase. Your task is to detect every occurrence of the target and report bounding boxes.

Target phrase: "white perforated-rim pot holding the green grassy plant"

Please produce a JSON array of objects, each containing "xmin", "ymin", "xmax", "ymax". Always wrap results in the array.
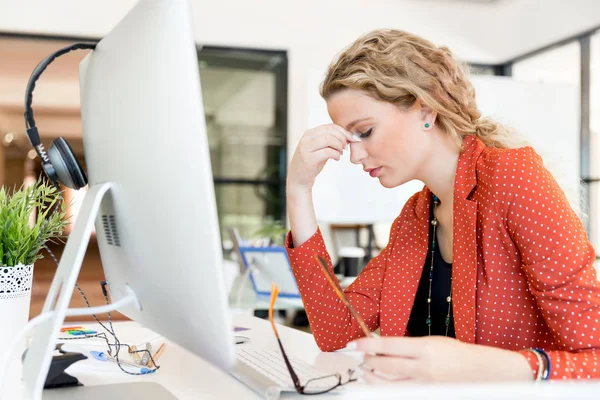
[{"xmin": 0, "ymin": 264, "xmax": 33, "ymax": 360}]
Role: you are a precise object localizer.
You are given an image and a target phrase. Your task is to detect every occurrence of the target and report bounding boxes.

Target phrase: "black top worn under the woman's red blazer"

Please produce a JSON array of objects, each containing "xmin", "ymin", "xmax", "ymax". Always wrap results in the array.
[{"xmin": 407, "ymin": 203, "xmax": 455, "ymax": 337}]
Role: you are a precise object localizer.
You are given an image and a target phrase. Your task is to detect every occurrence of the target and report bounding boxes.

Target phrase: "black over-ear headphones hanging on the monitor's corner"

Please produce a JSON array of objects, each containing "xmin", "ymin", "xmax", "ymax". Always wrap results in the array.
[{"xmin": 25, "ymin": 43, "xmax": 96, "ymax": 190}]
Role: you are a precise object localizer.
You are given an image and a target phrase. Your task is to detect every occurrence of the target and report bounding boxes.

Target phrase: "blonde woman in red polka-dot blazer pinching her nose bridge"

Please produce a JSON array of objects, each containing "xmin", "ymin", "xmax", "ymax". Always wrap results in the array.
[{"xmin": 287, "ymin": 30, "xmax": 600, "ymax": 382}]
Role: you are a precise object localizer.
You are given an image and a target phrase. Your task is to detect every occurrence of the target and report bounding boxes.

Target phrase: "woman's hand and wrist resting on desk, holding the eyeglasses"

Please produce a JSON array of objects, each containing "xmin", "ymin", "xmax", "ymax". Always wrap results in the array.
[{"xmin": 354, "ymin": 336, "xmax": 533, "ymax": 383}]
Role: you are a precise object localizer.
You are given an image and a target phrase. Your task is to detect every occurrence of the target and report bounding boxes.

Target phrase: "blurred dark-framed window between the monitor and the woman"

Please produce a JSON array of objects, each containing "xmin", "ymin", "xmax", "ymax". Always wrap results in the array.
[{"xmin": 198, "ymin": 47, "xmax": 287, "ymax": 244}]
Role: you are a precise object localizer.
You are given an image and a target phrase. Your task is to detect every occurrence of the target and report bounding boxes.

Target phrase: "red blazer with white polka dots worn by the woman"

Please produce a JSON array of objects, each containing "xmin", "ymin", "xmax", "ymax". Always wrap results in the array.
[{"xmin": 287, "ymin": 136, "xmax": 600, "ymax": 379}]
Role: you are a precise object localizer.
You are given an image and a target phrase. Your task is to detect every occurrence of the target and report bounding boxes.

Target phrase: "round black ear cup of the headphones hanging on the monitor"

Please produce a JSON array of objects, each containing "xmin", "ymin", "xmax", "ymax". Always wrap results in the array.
[{"xmin": 48, "ymin": 137, "xmax": 88, "ymax": 190}]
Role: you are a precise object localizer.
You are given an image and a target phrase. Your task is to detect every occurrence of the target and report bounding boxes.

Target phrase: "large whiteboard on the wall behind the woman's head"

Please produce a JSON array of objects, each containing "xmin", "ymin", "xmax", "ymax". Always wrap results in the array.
[{"xmin": 307, "ymin": 74, "xmax": 579, "ymax": 224}]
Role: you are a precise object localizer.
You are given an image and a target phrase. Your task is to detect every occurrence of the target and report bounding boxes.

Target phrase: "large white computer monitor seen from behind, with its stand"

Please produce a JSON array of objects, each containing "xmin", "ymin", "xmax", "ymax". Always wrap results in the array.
[{"xmin": 24, "ymin": 0, "xmax": 235, "ymax": 397}]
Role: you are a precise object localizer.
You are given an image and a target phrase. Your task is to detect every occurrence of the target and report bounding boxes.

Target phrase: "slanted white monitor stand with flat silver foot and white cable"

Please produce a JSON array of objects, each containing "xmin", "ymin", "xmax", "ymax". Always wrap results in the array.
[{"xmin": 18, "ymin": 182, "xmax": 175, "ymax": 400}]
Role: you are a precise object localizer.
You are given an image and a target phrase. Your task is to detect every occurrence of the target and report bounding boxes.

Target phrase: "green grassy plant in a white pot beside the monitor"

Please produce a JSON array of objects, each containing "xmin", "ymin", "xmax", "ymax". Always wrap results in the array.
[{"xmin": 0, "ymin": 180, "xmax": 68, "ymax": 356}]
